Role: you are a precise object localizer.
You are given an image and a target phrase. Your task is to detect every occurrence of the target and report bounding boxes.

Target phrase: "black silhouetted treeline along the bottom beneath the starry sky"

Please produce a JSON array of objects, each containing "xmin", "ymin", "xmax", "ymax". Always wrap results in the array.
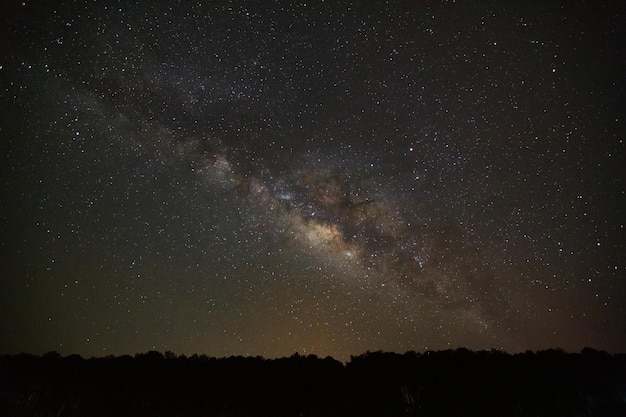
[{"xmin": 0, "ymin": 348, "xmax": 626, "ymax": 417}]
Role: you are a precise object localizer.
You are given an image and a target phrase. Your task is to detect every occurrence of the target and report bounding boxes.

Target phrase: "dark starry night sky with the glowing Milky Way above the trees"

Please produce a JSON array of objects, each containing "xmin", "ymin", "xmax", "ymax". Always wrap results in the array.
[{"xmin": 0, "ymin": 1, "xmax": 626, "ymax": 360}]
